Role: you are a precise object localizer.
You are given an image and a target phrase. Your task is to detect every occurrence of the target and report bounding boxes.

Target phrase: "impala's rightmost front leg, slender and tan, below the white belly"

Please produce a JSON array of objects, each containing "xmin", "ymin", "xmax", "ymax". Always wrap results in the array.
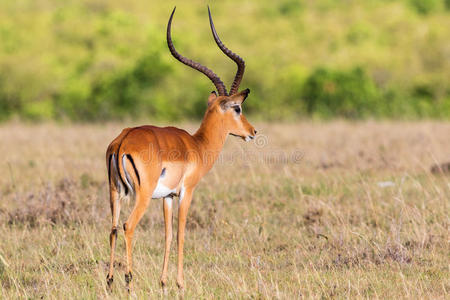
[{"xmin": 177, "ymin": 188, "xmax": 193, "ymax": 292}]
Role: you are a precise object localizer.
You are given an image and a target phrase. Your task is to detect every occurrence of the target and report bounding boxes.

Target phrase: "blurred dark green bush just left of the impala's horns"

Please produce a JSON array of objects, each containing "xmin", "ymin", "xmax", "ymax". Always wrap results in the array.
[{"xmin": 55, "ymin": 52, "xmax": 169, "ymax": 121}]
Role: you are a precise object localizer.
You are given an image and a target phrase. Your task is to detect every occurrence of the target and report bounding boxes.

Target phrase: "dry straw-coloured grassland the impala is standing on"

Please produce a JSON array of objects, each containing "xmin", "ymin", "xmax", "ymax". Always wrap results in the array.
[{"xmin": 0, "ymin": 121, "xmax": 450, "ymax": 299}]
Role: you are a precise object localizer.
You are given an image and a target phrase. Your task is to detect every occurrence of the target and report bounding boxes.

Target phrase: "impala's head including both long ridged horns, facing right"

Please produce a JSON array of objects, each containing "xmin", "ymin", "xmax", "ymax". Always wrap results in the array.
[{"xmin": 167, "ymin": 7, "xmax": 256, "ymax": 141}]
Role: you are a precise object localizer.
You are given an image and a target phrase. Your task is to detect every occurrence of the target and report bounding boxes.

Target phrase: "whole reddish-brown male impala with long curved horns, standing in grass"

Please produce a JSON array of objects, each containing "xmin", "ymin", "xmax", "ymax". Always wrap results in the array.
[{"xmin": 106, "ymin": 8, "xmax": 256, "ymax": 290}]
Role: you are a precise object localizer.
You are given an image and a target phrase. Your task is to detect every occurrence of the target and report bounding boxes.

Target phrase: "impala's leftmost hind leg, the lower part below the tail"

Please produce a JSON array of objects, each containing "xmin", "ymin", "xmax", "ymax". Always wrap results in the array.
[{"xmin": 106, "ymin": 186, "xmax": 120, "ymax": 288}]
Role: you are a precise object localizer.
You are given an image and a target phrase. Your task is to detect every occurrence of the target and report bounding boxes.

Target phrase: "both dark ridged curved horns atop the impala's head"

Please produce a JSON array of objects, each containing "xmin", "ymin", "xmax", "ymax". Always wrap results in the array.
[{"xmin": 167, "ymin": 6, "xmax": 245, "ymax": 96}]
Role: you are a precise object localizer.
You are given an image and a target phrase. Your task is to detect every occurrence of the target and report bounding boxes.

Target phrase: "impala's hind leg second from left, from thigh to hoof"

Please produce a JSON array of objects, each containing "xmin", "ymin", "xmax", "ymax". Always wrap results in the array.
[{"xmin": 123, "ymin": 188, "xmax": 153, "ymax": 291}]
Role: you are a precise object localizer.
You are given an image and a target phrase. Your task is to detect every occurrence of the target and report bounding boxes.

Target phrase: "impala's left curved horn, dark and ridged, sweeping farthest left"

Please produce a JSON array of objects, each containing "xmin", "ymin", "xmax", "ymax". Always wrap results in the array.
[{"xmin": 167, "ymin": 7, "xmax": 228, "ymax": 96}]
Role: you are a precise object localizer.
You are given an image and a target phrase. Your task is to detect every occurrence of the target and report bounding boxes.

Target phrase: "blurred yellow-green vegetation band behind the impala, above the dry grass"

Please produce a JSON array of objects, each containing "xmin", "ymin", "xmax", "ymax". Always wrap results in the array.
[{"xmin": 0, "ymin": 0, "xmax": 450, "ymax": 121}]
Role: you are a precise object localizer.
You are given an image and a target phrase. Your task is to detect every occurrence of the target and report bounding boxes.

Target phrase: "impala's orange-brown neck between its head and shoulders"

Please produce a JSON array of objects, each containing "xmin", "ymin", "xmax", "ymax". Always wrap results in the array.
[{"xmin": 194, "ymin": 114, "xmax": 228, "ymax": 168}]
